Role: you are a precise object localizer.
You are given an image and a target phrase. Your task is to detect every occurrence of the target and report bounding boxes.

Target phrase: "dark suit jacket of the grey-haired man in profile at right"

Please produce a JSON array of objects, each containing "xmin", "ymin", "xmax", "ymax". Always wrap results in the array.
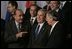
[{"xmin": 47, "ymin": 22, "xmax": 64, "ymax": 48}]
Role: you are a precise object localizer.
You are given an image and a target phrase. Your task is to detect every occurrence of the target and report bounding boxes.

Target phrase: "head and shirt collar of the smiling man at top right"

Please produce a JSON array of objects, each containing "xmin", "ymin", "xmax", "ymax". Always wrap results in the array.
[{"xmin": 49, "ymin": 1, "xmax": 61, "ymax": 17}]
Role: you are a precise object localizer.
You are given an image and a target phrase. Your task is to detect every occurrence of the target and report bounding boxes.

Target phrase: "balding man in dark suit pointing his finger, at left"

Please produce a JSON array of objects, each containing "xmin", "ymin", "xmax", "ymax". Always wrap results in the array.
[{"xmin": 4, "ymin": 9, "xmax": 29, "ymax": 48}]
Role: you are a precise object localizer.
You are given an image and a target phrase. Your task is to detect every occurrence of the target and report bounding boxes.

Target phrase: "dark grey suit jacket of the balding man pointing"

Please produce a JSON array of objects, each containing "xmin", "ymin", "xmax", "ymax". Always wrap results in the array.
[{"xmin": 4, "ymin": 20, "xmax": 29, "ymax": 48}]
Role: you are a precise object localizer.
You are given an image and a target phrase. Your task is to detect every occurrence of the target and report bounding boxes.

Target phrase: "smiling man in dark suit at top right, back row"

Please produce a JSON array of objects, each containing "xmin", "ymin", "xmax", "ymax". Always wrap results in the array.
[{"xmin": 44, "ymin": 1, "xmax": 62, "ymax": 21}]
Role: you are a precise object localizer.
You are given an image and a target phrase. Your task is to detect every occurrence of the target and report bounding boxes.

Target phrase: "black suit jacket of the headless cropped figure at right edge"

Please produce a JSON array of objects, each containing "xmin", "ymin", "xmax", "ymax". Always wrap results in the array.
[{"xmin": 61, "ymin": 1, "xmax": 71, "ymax": 33}]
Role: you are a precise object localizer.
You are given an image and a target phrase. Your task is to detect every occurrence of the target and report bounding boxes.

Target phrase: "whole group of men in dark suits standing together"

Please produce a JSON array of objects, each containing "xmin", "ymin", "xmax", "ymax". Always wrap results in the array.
[{"xmin": 1, "ymin": 1, "xmax": 71, "ymax": 48}]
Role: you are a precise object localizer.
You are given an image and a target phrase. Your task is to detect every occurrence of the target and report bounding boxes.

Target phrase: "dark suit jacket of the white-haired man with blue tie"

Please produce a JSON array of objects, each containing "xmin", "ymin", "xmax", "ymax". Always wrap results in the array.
[{"xmin": 28, "ymin": 22, "xmax": 48, "ymax": 48}]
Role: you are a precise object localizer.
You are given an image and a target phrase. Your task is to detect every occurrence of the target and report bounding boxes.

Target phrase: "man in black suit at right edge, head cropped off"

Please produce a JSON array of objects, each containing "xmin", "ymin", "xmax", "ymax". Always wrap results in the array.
[{"xmin": 61, "ymin": 1, "xmax": 72, "ymax": 47}]
